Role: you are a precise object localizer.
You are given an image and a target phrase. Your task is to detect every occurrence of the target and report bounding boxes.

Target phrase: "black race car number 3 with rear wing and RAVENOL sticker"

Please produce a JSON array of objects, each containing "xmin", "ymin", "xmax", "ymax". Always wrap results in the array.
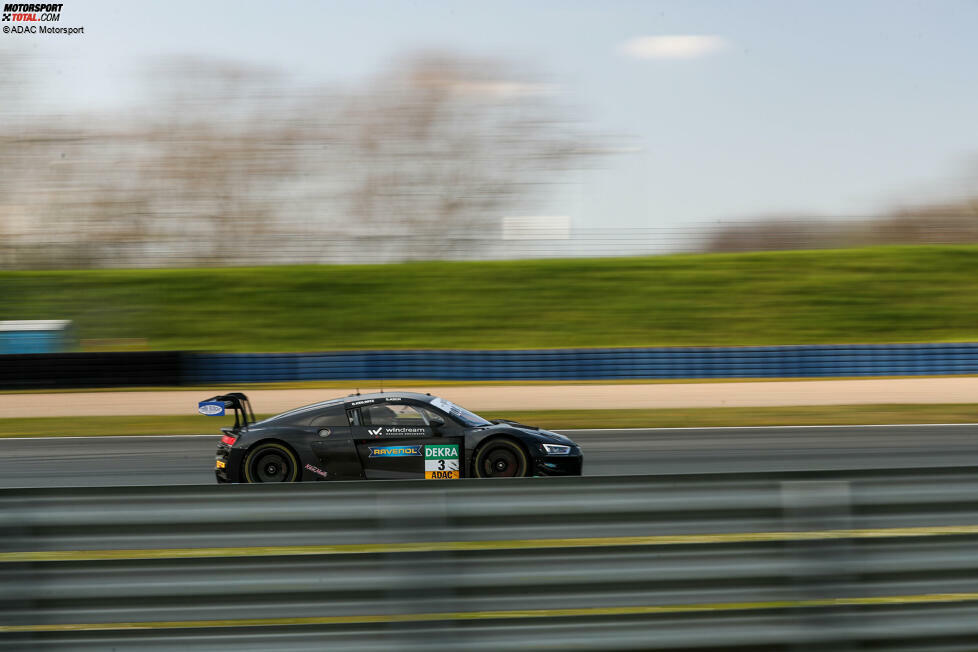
[{"xmin": 197, "ymin": 392, "xmax": 582, "ymax": 482}]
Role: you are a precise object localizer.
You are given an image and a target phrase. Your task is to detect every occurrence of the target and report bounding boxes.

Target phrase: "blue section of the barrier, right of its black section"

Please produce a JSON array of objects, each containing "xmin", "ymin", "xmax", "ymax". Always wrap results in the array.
[{"xmin": 184, "ymin": 342, "xmax": 978, "ymax": 384}]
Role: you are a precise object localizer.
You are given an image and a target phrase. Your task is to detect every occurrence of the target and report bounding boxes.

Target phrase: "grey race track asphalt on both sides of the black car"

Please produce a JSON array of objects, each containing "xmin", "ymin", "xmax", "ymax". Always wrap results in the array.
[{"xmin": 0, "ymin": 424, "xmax": 978, "ymax": 487}]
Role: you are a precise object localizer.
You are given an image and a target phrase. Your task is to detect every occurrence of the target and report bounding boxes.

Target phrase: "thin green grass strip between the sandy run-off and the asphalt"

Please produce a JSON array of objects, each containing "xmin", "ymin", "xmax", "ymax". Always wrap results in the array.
[{"xmin": 0, "ymin": 403, "xmax": 978, "ymax": 437}]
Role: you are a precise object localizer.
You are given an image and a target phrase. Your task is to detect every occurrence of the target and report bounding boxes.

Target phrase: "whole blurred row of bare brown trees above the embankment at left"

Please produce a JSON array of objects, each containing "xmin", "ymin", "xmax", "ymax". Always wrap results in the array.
[{"xmin": 0, "ymin": 54, "xmax": 608, "ymax": 267}]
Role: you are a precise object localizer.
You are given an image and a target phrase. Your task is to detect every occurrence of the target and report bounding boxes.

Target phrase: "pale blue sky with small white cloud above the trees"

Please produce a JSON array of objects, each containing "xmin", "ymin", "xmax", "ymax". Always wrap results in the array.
[{"xmin": 7, "ymin": 0, "xmax": 978, "ymax": 241}]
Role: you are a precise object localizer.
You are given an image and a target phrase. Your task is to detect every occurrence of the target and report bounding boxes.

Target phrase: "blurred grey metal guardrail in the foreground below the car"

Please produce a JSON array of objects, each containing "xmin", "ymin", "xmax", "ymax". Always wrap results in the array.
[{"xmin": 0, "ymin": 467, "xmax": 978, "ymax": 651}]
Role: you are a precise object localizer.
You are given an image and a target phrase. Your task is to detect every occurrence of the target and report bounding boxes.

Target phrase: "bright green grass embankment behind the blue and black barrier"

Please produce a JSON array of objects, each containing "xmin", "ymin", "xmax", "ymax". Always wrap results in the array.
[{"xmin": 0, "ymin": 246, "xmax": 978, "ymax": 351}]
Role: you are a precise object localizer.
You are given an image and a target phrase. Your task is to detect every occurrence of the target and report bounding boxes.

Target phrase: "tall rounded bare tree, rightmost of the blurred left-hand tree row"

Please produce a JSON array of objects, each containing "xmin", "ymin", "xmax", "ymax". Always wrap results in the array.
[{"xmin": 316, "ymin": 53, "xmax": 594, "ymax": 259}]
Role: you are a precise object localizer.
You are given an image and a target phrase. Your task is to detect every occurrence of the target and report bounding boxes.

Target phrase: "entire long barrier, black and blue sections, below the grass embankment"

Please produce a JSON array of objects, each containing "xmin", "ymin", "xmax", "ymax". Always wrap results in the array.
[{"xmin": 0, "ymin": 342, "xmax": 978, "ymax": 389}]
